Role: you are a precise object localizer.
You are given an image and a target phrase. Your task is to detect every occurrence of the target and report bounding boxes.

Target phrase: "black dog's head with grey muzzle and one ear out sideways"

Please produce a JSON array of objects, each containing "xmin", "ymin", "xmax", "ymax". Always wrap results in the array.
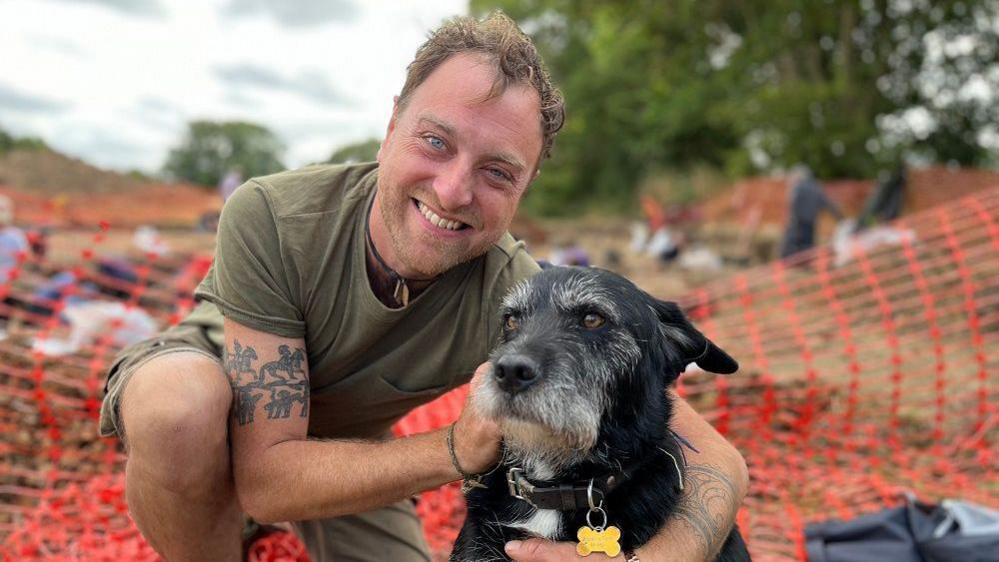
[{"xmin": 474, "ymin": 267, "xmax": 738, "ymax": 472}]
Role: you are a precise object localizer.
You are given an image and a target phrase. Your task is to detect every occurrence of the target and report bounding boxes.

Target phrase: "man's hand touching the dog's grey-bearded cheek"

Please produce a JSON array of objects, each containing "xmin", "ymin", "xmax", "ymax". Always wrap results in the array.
[{"xmin": 454, "ymin": 362, "xmax": 503, "ymax": 474}]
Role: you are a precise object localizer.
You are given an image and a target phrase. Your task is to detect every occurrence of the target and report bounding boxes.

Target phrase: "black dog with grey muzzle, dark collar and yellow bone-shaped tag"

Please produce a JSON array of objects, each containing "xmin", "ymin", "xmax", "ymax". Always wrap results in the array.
[{"xmin": 451, "ymin": 267, "xmax": 749, "ymax": 562}]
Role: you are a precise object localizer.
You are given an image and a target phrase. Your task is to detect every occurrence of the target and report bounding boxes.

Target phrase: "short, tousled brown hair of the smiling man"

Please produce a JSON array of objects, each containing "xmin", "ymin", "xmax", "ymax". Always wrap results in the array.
[{"xmin": 399, "ymin": 11, "xmax": 565, "ymax": 165}]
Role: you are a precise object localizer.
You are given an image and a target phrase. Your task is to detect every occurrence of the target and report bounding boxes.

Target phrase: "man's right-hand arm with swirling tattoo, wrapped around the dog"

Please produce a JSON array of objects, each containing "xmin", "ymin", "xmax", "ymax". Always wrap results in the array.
[{"xmin": 507, "ymin": 395, "xmax": 749, "ymax": 562}]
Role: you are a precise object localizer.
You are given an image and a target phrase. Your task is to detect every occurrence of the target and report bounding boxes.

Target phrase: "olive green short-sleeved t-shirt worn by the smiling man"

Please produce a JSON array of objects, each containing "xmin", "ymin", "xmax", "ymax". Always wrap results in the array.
[{"xmin": 195, "ymin": 163, "xmax": 538, "ymax": 437}]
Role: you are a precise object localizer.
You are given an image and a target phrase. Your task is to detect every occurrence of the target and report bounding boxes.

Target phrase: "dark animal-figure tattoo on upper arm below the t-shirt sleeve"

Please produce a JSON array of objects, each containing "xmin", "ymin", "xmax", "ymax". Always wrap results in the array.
[{"xmin": 224, "ymin": 340, "xmax": 309, "ymax": 425}]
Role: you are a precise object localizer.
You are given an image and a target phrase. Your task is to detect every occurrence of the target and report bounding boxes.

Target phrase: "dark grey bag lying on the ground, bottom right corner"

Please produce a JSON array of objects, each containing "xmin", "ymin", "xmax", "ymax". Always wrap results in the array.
[{"xmin": 805, "ymin": 498, "xmax": 999, "ymax": 562}]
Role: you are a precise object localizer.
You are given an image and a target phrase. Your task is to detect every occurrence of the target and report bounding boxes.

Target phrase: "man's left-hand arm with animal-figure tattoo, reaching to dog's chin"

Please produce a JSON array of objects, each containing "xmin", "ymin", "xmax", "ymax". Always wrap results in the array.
[{"xmin": 225, "ymin": 319, "xmax": 499, "ymax": 523}]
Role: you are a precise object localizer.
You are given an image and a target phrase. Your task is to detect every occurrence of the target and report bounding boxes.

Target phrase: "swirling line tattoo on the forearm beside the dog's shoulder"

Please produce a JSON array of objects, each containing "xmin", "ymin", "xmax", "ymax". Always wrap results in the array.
[{"xmin": 677, "ymin": 465, "xmax": 738, "ymax": 560}]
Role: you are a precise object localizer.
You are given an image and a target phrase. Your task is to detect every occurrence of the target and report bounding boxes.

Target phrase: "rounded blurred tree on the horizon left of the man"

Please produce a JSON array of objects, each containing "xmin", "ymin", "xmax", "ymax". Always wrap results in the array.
[{"xmin": 163, "ymin": 121, "xmax": 284, "ymax": 187}]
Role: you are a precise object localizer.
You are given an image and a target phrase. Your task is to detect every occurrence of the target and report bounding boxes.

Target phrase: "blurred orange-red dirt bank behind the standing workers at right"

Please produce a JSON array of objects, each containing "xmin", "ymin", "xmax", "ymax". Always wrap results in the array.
[{"xmin": 701, "ymin": 167, "xmax": 999, "ymax": 225}]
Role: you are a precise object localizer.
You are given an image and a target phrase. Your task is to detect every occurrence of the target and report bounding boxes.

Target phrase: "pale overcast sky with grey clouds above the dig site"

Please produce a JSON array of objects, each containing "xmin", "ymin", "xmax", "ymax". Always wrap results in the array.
[{"xmin": 0, "ymin": 0, "xmax": 467, "ymax": 172}]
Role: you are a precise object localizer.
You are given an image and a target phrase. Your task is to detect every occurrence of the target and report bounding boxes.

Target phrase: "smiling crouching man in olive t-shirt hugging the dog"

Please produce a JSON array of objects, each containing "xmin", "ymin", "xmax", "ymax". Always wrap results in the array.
[{"xmin": 101, "ymin": 9, "xmax": 746, "ymax": 562}]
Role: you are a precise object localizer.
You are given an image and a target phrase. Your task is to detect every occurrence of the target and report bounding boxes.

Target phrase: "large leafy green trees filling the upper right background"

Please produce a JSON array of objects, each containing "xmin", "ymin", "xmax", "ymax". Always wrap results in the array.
[{"xmin": 471, "ymin": 0, "xmax": 999, "ymax": 213}]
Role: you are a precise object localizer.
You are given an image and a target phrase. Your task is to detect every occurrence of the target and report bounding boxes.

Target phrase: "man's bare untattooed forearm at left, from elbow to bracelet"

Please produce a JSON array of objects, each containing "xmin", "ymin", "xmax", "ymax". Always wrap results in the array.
[{"xmin": 233, "ymin": 431, "xmax": 458, "ymax": 523}]
